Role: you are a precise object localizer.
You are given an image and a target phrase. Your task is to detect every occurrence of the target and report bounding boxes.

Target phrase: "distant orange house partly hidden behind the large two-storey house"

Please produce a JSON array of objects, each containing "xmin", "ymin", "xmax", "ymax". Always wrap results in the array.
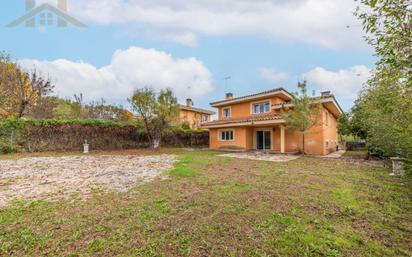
[{"xmin": 179, "ymin": 99, "xmax": 215, "ymax": 129}]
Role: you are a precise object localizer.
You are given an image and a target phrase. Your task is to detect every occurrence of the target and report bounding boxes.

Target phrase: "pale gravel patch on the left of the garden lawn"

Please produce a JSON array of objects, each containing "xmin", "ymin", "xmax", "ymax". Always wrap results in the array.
[{"xmin": 0, "ymin": 154, "xmax": 176, "ymax": 206}]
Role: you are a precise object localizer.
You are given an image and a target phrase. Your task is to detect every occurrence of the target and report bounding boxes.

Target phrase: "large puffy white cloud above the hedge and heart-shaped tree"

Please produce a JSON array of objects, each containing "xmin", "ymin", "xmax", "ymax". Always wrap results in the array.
[{"xmin": 20, "ymin": 47, "xmax": 213, "ymax": 102}]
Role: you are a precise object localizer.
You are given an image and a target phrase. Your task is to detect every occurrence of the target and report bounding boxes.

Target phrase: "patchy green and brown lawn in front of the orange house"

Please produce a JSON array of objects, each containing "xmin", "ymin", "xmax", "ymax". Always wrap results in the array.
[{"xmin": 0, "ymin": 150, "xmax": 412, "ymax": 256}]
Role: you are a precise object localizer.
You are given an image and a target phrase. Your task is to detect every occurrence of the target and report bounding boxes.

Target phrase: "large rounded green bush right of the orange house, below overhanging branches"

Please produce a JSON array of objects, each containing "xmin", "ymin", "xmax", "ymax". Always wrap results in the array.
[{"xmin": 351, "ymin": 72, "xmax": 412, "ymax": 156}]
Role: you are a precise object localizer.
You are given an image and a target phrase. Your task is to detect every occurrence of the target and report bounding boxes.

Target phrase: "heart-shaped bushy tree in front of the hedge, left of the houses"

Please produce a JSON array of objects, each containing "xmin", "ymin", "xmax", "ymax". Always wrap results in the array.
[{"xmin": 128, "ymin": 87, "xmax": 179, "ymax": 149}]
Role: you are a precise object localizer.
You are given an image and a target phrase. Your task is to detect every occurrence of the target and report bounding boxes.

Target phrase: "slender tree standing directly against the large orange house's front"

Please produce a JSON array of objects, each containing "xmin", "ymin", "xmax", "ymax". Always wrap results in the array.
[{"xmin": 282, "ymin": 81, "xmax": 321, "ymax": 154}]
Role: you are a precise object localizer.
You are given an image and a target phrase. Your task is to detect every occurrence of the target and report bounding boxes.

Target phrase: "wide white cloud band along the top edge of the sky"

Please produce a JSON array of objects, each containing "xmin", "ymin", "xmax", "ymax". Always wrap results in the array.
[{"xmin": 65, "ymin": 0, "xmax": 366, "ymax": 49}]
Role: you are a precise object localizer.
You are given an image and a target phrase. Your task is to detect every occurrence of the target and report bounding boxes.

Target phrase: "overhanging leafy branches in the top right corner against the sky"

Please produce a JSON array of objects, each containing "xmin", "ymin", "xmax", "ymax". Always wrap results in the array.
[{"xmin": 355, "ymin": 0, "xmax": 412, "ymax": 86}]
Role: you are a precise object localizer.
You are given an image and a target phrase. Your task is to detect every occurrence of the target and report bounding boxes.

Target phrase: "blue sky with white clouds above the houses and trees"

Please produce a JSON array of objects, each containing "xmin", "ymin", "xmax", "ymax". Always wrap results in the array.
[{"xmin": 0, "ymin": 0, "xmax": 375, "ymax": 110}]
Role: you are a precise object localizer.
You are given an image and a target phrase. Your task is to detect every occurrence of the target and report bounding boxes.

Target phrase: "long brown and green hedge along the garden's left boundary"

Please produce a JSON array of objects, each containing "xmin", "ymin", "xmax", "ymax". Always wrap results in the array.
[{"xmin": 0, "ymin": 119, "xmax": 209, "ymax": 153}]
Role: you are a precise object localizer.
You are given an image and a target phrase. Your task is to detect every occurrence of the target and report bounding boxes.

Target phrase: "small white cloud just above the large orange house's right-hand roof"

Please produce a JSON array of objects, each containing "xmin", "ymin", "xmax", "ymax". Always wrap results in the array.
[{"xmin": 301, "ymin": 65, "xmax": 371, "ymax": 107}]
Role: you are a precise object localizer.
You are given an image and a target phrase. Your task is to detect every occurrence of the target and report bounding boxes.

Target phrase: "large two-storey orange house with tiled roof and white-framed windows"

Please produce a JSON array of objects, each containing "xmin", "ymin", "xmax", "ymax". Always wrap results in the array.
[{"xmin": 202, "ymin": 88, "xmax": 343, "ymax": 155}]
